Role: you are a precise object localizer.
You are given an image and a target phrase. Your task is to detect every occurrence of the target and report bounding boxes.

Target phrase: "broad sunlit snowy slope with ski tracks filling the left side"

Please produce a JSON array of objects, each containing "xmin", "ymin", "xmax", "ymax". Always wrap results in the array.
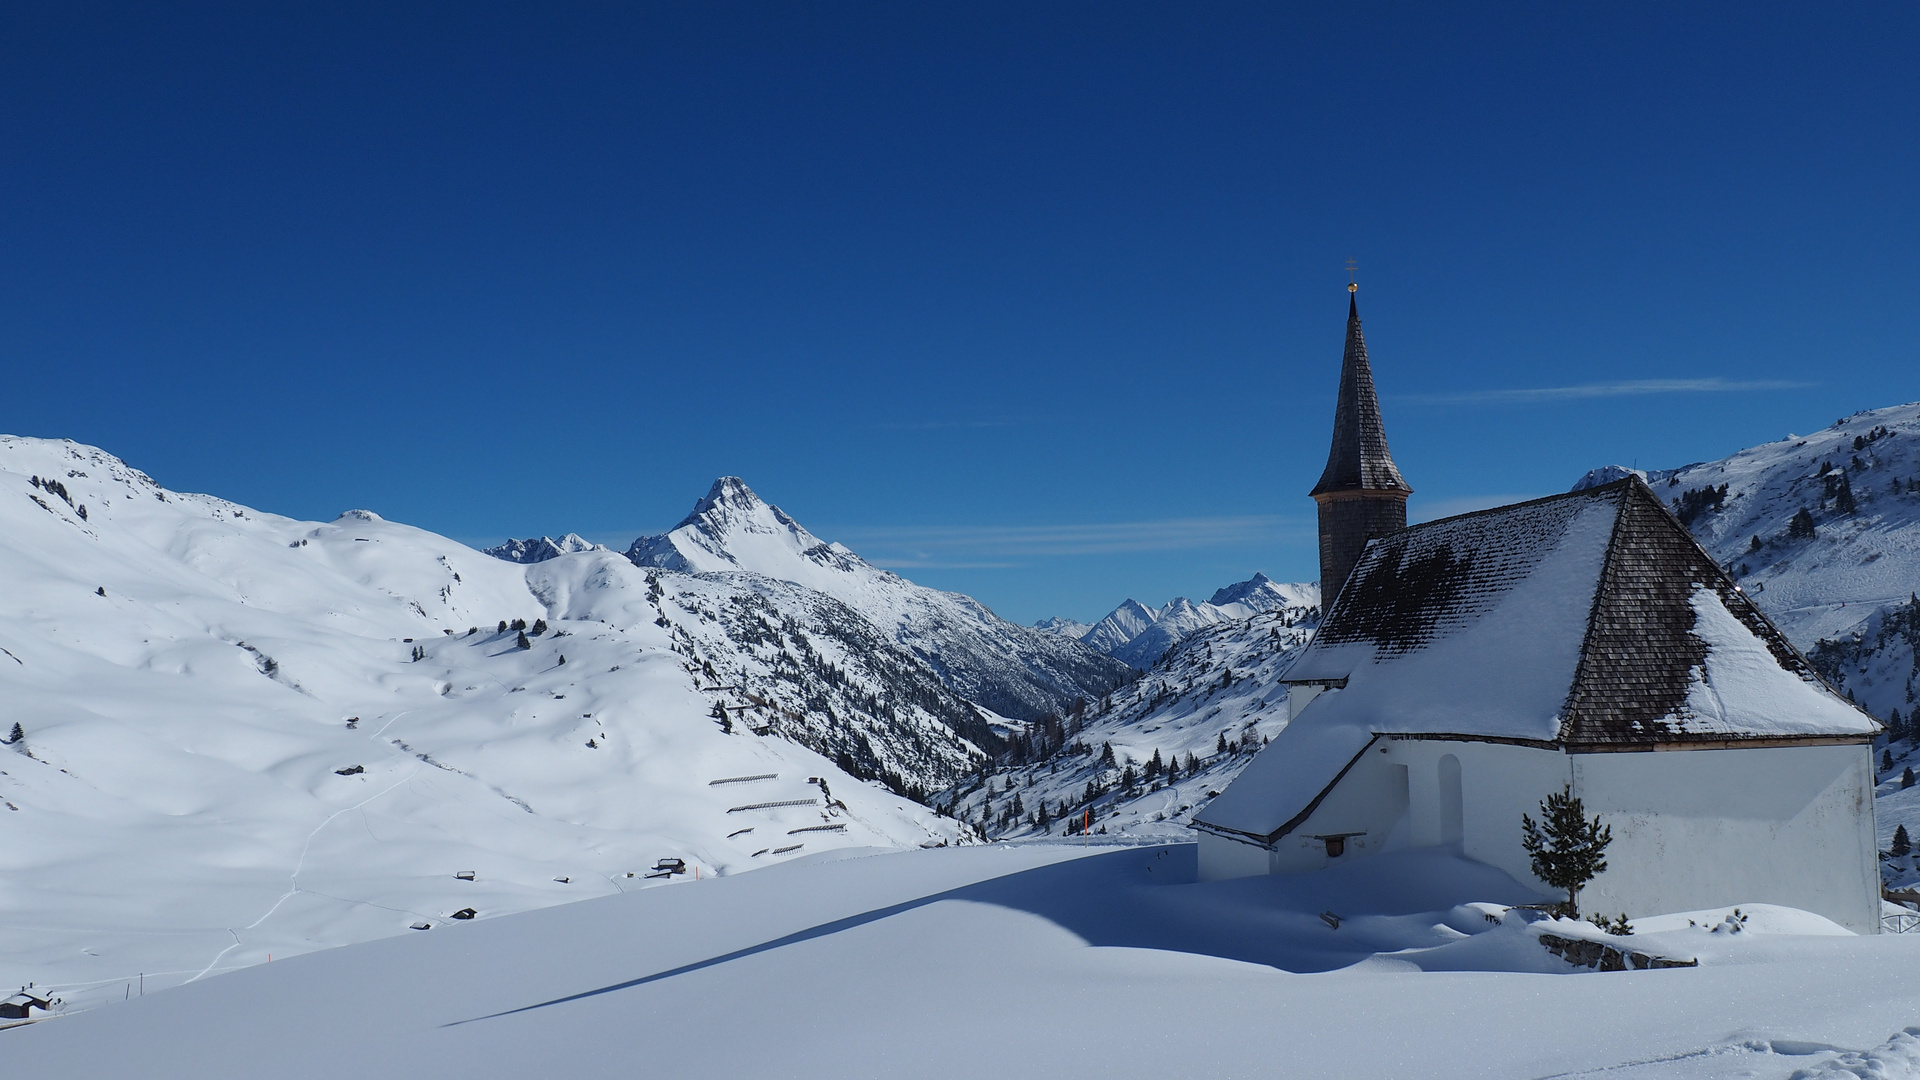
[{"xmin": 0, "ymin": 436, "xmax": 960, "ymax": 1001}]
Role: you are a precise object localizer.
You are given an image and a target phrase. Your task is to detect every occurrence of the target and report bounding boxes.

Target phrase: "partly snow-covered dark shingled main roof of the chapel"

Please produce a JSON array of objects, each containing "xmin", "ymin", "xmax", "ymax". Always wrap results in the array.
[{"xmin": 1194, "ymin": 477, "xmax": 1880, "ymax": 838}]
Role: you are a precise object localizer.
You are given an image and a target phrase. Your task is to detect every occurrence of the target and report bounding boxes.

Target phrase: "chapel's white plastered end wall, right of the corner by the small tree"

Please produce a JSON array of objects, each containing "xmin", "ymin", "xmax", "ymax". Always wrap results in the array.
[{"xmin": 1572, "ymin": 746, "xmax": 1880, "ymax": 934}]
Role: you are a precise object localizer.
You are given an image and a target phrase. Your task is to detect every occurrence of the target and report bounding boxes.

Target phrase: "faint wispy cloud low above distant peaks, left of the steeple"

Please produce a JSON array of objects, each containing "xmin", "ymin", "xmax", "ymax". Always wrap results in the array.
[{"xmin": 839, "ymin": 515, "xmax": 1313, "ymax": 569}]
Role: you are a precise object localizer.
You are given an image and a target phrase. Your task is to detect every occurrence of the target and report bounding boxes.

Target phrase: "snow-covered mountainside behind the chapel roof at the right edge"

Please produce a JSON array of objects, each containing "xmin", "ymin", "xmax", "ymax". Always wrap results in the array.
[{"xmin": 1576, "ymin": 404, "xmax": 1920, "ymax": 719}]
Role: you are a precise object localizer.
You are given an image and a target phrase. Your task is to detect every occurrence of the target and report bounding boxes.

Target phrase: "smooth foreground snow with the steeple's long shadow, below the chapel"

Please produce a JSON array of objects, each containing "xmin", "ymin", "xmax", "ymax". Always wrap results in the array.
[{"xmin": 15, "ymin": 842, "xmax": 1920, "ymax": 1080}]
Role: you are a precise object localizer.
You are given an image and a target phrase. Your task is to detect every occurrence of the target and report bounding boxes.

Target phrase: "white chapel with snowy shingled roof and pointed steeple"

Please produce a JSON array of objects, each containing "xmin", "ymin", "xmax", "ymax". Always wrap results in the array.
[{"xmin": 1192, "ymin": 284, "xmax": 1882, "ymax": 934}]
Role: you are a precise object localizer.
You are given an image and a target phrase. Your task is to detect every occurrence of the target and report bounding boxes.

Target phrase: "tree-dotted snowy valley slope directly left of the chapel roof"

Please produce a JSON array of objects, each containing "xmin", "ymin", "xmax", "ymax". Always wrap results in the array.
[{"xmin": 937, "ymin": 607, "xmax": 1317, "ymax": 838}]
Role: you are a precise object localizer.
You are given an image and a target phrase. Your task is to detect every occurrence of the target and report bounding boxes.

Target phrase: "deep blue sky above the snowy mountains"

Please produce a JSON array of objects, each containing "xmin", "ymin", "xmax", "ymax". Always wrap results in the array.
[{"xmin": 0, "ymin": 2, "xmax": 1920, "ymax": 621}]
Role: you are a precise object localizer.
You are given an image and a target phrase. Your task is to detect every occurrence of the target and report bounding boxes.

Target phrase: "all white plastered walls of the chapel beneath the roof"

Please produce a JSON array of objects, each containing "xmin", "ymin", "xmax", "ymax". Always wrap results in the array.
[{"xmin": 1200, "ymin": 736, "xmax": 1880, "ymax": 934}]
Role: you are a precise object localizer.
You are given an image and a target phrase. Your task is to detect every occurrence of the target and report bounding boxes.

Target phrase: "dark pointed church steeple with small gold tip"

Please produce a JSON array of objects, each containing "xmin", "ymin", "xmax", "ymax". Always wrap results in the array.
[{"xmin": 1309, "ymin": 284, "xmax": 1413, "ymax": 609}]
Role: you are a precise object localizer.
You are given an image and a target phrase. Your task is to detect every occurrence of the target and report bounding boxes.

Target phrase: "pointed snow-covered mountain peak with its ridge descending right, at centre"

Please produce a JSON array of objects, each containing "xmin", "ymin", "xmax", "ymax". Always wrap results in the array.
[{"xmin": 626, "ymin": 477, "xmax": 1131, "ymax": 719}]
